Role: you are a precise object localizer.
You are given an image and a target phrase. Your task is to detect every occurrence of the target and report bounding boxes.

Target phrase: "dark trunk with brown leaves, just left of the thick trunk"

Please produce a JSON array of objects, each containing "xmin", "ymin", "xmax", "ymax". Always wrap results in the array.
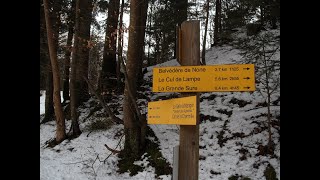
[{"xmin": 99, "ymin": 0, "xmax": 120, "ymax": 91}]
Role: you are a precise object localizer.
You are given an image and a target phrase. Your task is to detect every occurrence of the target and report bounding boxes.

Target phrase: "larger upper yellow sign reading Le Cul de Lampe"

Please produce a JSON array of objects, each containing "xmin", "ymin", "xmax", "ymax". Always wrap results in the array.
[{"xmin": 152, "ymin": 64, "xmax": 256, "ymax": 92}]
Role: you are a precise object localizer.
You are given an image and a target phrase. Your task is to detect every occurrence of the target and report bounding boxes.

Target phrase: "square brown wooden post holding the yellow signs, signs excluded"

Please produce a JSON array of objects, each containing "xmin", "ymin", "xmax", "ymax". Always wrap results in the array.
[{"xmin": 179, "ymin": 20, "xmax": 200, "ymax": 180}]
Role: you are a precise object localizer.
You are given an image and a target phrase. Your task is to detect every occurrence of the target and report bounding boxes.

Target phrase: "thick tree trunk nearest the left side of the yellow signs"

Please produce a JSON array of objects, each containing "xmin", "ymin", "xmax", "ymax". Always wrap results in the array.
[{"xmin": 123, "ymin": 0, "xmax": 147, "ymax": 158}]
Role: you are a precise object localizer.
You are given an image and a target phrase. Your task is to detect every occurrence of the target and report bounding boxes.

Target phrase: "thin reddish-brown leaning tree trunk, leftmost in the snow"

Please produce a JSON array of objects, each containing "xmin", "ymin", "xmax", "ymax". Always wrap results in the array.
[{"xmin": 44, "ymin": 0, "xmax": 66, "ymax": 143}]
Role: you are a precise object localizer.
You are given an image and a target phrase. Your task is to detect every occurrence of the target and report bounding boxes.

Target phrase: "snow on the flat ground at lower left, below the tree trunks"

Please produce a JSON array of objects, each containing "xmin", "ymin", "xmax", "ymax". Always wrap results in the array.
[{"xmin": 40, "ymin": 98, "xmax": 170, "ymax": 180}]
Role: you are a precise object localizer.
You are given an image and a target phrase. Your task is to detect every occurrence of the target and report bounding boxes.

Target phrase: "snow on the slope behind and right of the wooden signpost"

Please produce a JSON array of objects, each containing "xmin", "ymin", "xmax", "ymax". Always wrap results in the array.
[{"xmin": 145, "ymin": 27, "xmax": 280, "ymax": 180}]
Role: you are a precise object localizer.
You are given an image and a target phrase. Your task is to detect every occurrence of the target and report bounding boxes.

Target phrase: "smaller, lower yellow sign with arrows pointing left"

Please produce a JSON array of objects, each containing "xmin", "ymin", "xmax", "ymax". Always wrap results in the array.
[{"xmin": 148, "ymin": 96, "xmax": 197, "ymax": 125}]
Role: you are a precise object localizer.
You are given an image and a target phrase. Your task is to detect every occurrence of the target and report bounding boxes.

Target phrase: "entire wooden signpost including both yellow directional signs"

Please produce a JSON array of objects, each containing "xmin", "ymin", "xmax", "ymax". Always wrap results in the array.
[{"xmin": 148, "ymin": 20, "xmax": 256, "ymax": 180}]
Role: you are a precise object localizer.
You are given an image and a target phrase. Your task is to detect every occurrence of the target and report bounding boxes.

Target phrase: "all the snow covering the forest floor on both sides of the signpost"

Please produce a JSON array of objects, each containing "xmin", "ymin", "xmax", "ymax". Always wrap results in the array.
[{"xmin": 40, "ymin": 27, "xmax": 280, "ymax": 180}]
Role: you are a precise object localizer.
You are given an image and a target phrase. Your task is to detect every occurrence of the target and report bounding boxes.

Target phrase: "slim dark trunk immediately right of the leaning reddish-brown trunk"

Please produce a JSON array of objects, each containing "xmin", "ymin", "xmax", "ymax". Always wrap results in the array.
[{"xmin": 63, "ymin": 0, "xmax": 75, "ymax": 101}]
